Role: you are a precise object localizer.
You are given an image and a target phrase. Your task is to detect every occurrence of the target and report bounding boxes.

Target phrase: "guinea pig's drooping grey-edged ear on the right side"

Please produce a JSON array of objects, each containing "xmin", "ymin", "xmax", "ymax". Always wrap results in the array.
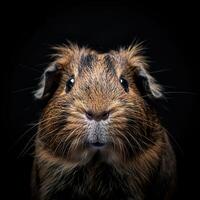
[{"xmin": 135, "ymin": 66, "xmax": 163, "ymax": 99}]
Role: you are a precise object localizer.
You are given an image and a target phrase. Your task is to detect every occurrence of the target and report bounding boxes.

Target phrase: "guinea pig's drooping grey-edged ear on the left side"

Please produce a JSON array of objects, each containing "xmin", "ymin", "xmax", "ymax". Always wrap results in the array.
[{"xmin": 34, "ymin": 63, "xmax": 61, "ymax": 99}]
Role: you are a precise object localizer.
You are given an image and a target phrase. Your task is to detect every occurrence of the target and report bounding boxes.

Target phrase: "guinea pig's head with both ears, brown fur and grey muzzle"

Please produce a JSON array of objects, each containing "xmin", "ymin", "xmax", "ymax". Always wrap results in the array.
[{"xmin": 35, "ymin": 45, "xmax": 162, "ymax": 165}]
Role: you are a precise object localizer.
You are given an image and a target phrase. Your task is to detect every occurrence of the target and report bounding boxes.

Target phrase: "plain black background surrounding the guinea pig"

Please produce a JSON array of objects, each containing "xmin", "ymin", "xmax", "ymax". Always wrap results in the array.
[{"xmin": 1, "ymin": 1, "xmax": 199, "ymax": 199}]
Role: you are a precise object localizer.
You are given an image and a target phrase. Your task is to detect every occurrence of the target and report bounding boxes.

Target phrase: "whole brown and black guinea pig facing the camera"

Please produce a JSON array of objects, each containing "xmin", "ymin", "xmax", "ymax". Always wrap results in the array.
[{"xmin": 31, "ymin": 44, "xmax": 176, "ymax": 200}]
